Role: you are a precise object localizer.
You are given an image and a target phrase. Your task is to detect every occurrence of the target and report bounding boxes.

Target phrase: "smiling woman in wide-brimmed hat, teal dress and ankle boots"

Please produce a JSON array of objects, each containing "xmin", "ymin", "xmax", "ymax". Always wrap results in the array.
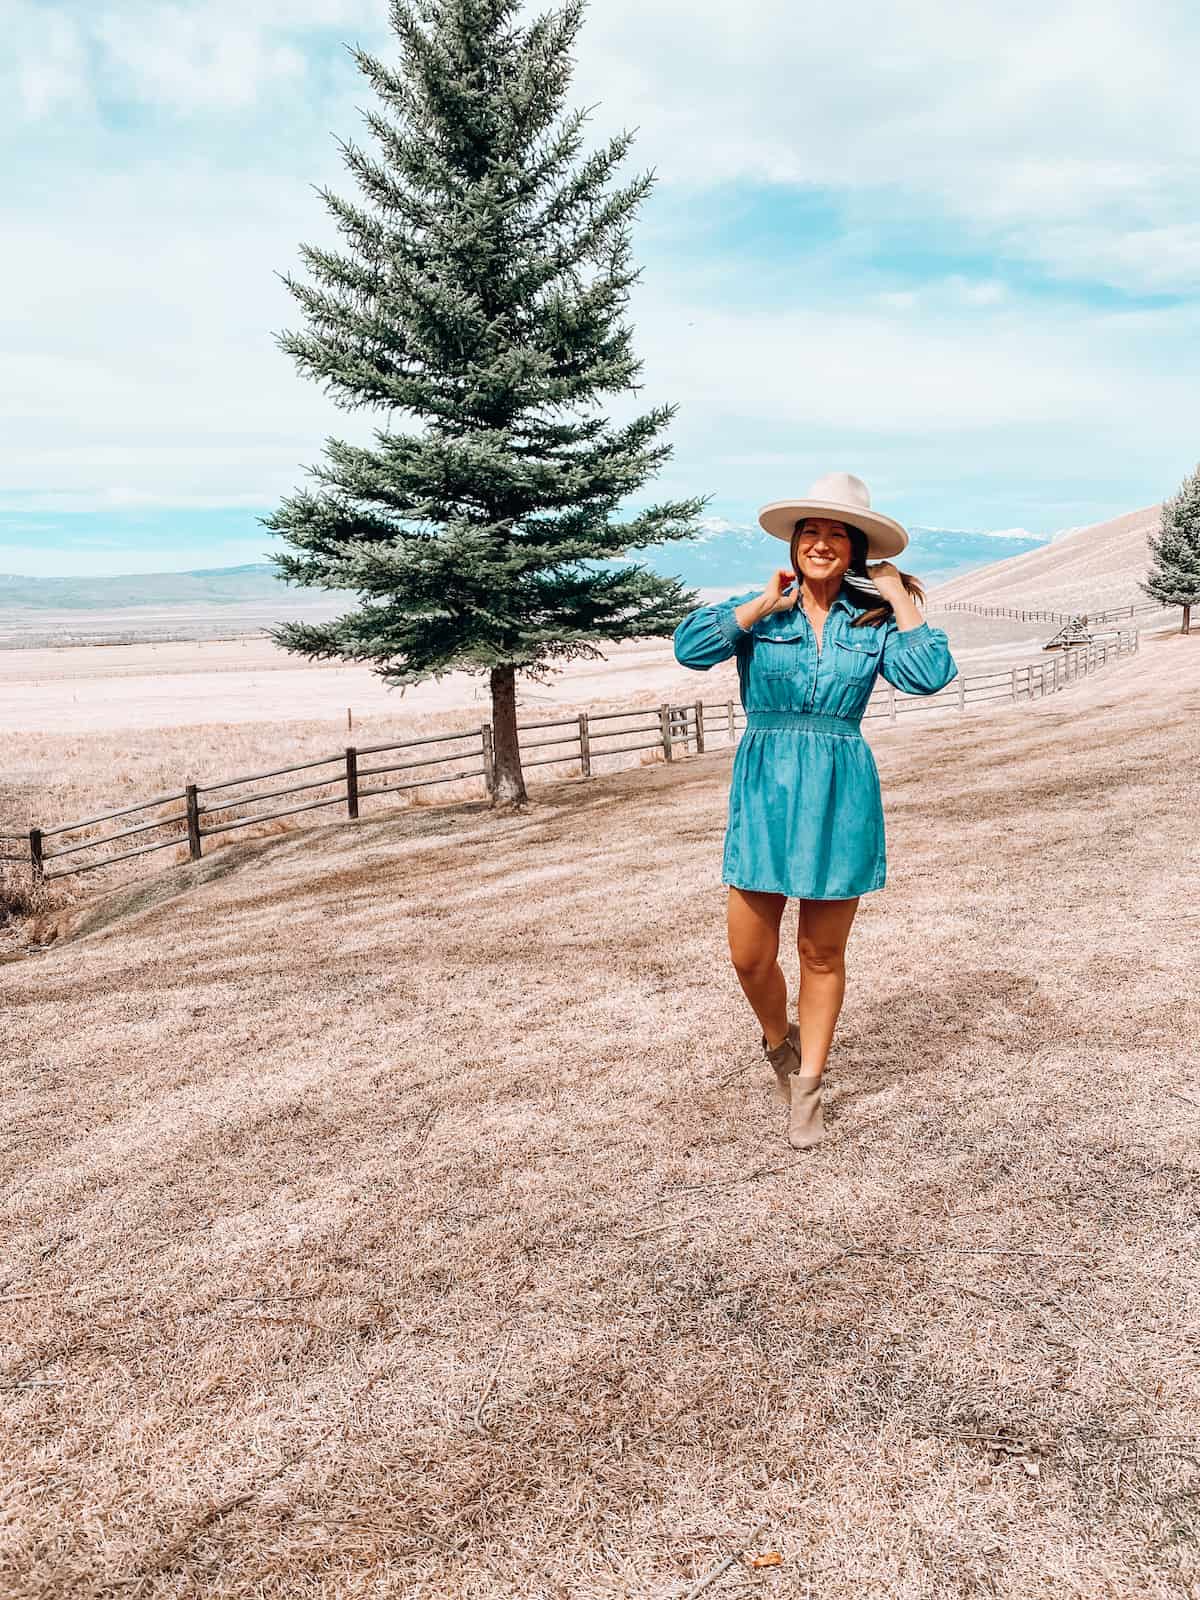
[{"xmin": 675, "ymin": 472, "xmax": 958, "ymax": 1150}]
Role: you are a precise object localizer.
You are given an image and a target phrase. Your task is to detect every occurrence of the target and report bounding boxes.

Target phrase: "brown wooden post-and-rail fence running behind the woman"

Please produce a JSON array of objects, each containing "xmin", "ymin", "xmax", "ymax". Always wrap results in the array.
[{"xmin": 0, "ymin": 630, "xmax": 1138, "ymax": 882}]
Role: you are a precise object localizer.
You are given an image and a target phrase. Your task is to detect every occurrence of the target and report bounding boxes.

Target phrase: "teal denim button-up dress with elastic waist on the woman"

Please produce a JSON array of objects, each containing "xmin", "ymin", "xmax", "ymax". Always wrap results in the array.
[{"xmin": 674, "ymin": 587, "xmax": 958, "ymax": 899}]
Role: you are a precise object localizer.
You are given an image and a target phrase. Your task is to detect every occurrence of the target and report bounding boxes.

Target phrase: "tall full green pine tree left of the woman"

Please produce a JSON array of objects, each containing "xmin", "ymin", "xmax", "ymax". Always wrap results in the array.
[{"xmin": 262, "ymin": 0, "xmax": 707, "ymax": 805}]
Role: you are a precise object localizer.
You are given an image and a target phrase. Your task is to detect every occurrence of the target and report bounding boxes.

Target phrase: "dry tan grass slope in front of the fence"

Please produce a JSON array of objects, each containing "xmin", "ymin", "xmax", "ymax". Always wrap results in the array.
[{"xmin": 0, "ymin": 614, "xmax": 1200, "ymax": 1600}]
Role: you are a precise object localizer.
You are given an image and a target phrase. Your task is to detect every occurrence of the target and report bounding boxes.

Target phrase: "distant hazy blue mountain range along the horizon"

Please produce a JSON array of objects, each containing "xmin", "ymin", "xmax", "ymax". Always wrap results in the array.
[{"xmin": 0, "ymin": 531, "xmax": 1051, "ymax": 616}]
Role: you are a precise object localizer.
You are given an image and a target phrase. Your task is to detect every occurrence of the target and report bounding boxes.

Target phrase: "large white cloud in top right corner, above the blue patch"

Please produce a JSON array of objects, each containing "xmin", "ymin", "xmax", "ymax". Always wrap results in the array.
[{"xmin": 574, "ymin": 0, "xmax": 1200, "ymax": 290}]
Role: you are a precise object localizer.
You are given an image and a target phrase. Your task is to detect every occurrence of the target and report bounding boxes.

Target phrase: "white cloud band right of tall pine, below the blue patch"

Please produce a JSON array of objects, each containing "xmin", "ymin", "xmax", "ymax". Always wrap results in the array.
[{"xmin": 635, "ymin": 281, "xmax": 1197, "ymax": 432}]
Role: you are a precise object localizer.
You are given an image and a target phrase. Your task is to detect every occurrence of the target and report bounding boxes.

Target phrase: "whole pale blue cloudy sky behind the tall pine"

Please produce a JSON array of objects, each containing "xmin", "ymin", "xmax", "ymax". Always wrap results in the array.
[{"xmin": 0, "ymin": 0, "xmax": 1200, "ymax": 574}]
